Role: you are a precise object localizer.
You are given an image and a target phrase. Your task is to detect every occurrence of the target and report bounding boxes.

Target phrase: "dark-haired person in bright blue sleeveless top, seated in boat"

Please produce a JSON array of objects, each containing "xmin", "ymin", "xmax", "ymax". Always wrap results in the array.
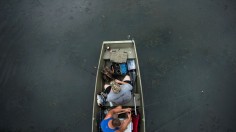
[{"xmin": 100, "ymin": 106, "xmax": 132, "ymax": 132}]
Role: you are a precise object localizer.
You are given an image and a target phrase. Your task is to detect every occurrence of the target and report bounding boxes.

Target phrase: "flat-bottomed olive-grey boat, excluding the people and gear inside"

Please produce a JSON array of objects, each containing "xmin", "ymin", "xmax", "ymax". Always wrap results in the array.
[{"xmin": 92, "ymin": 40, "xmax": 145, "ymax": 132}]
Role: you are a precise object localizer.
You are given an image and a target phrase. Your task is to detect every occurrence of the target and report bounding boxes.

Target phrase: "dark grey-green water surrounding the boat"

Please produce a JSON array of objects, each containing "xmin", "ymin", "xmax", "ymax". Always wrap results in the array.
[{"xmin": 0, "ymin": 0, "xmax": 236, "ymax": 132}]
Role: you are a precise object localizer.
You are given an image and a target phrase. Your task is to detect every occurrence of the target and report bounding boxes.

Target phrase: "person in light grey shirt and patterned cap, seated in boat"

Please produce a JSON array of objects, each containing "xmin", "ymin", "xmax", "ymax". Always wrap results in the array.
[{"xmin": 104, "ymin": 75, "xmax": 133, "ymax": 105}]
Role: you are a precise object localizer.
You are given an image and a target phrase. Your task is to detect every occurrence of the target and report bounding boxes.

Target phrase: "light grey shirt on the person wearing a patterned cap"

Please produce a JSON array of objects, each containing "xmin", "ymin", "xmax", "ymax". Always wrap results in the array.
[{"xmin": 107, "ymin": 83, "xmax": 133, "ymax": 105}]
